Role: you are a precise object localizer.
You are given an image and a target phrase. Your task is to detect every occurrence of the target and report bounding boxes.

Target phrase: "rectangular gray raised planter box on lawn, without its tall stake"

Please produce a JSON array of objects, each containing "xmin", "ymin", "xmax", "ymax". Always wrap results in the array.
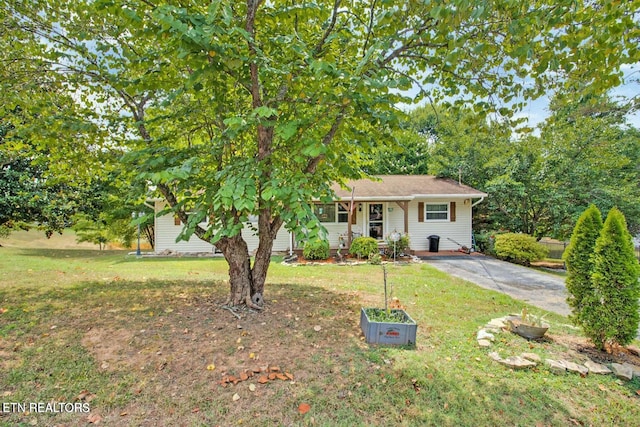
[{"xmin": 360, "ymin": 308, "xmax": 418, "ymax": 345}]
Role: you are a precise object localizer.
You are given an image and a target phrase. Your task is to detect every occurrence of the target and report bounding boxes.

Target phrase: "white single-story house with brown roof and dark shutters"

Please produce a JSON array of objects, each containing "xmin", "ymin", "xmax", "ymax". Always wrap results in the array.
[{"xmin": 155, "ymin": 175, "xmax": 487, "ymax": 253}]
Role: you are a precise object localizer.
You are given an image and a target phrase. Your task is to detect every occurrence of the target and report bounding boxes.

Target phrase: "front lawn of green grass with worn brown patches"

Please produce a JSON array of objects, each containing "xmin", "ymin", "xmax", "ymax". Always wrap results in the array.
[{"xmin": 0, "ymin": 232, "xmax": 640, "ymax": 426}]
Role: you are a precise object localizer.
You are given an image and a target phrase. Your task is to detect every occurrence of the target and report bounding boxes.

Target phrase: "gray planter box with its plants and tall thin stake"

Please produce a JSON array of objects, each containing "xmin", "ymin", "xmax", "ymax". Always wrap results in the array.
[{"xmin": 360, "ymin": 265, "xmax": 418, "ymax": 345}]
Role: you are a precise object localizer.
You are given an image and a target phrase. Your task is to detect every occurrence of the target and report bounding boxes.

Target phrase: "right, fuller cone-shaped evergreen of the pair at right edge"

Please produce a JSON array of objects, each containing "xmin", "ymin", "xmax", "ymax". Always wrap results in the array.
[{"xmin": 581, "ymin": 208, "xmax": 640, "ymax": 349}]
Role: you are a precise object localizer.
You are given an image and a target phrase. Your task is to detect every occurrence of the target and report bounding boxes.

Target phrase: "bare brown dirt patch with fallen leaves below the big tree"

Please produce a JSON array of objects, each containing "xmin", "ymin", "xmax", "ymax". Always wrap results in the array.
[{"xmin": 72, "ymin": 285, "xmax": 366, "ymax": 425}]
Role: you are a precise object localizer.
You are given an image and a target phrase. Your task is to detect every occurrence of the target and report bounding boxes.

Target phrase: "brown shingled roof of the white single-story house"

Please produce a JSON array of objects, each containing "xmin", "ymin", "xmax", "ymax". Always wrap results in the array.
[{"xmin": 331, "ymin": 175, "xmax": 487, "ymax": 200}]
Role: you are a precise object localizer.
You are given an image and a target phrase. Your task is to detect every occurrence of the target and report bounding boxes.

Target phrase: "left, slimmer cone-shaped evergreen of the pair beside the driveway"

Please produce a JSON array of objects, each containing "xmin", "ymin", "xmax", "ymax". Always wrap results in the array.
[{"xmin": 562, "ymin": 205, "xmax": 602, "ymax": 325}]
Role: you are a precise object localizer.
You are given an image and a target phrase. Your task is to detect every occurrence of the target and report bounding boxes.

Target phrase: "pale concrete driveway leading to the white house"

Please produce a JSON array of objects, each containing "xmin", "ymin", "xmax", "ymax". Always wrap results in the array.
[{"xmin": 424, "ymin": 255, "xmax": 571, "ymax": 316}]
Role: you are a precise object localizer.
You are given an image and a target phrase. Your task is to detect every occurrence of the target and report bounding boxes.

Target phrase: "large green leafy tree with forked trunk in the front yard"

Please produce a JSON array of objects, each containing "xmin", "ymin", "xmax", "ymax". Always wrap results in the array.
[{"xmin": 1, "ymin": 0, "xmax": 637, "ymax": 308}]
